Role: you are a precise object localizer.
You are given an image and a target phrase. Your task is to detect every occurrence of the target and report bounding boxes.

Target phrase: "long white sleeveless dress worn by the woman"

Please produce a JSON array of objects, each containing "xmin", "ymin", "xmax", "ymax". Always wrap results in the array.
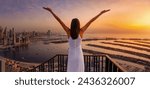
[{"xmin": 67, "ymin": 36, "xmax": 84, "ymax": 72}]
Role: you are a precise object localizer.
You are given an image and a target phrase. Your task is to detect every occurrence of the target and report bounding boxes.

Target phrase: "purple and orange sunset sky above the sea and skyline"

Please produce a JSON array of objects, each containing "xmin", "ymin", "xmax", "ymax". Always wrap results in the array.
[{"xmin": 0, "ymin": 0, "xmax": 150, "ymax": 34}]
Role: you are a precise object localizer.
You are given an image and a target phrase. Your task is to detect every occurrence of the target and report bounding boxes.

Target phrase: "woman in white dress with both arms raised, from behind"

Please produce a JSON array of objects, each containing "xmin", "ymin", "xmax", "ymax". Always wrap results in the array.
[{"xmin": 43, "ymin": 7, "xmax": 110, "ymax": 72}]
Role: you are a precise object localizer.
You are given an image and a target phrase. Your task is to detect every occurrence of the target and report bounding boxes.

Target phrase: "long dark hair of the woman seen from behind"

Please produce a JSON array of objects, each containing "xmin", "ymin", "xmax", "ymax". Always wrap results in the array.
[{"xmin": 70, "ymin": 18, "xmax": 80, "ymax": 39}]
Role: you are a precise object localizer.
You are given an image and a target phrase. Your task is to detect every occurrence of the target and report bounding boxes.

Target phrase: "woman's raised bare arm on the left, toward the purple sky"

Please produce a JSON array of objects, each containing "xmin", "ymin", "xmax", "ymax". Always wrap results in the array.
[{"xmin": 43, "ymin": 7, "xmax": 69, "ymax": 34}]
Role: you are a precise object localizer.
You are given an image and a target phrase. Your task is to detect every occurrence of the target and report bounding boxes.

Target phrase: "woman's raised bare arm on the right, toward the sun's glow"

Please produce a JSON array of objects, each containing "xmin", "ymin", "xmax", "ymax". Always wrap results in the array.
[{"xmin": 81, "ymin": 9, "xmax": 110, "ymax": 32}]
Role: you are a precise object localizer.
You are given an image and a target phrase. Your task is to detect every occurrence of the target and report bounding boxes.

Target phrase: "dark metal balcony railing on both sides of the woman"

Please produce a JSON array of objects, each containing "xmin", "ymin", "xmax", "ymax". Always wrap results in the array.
[{"xmin": 29, "ymin": 54, "xmax": 126, "ymax": 72}]
